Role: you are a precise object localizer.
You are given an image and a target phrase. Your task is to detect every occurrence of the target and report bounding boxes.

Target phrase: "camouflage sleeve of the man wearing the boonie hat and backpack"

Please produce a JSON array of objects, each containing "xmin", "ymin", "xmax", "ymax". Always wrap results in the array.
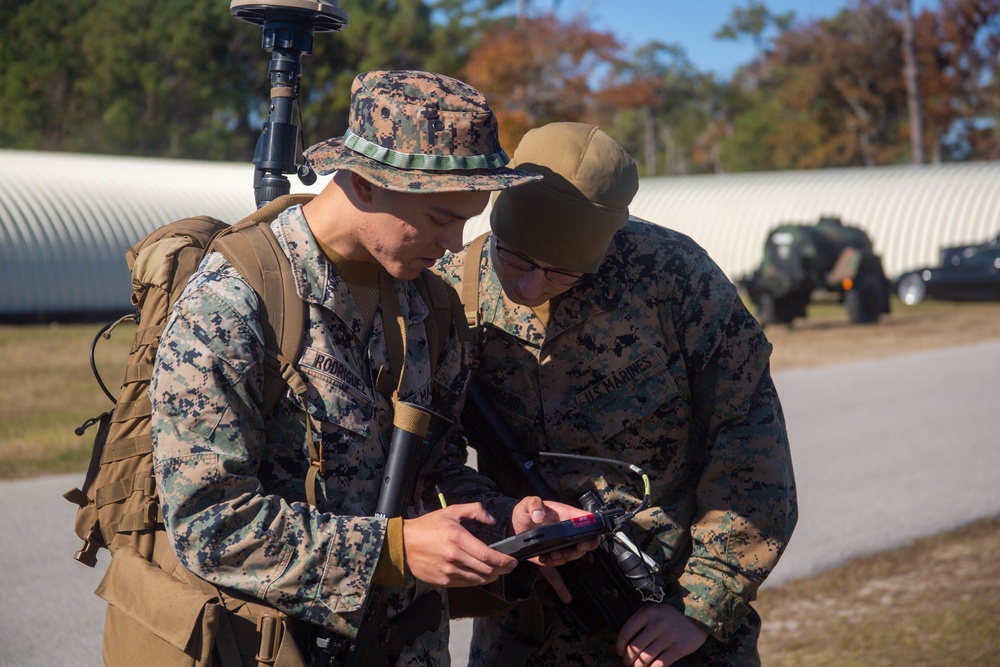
[{"xmin": 150, "ymin": 255, "xmax": 385, "ymax": 635}]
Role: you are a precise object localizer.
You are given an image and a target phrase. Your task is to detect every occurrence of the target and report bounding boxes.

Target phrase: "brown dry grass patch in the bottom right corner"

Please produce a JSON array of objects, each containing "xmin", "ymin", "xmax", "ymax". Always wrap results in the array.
[{"xmin": 755, "ymin": 517, "xmax": 1000, "ymax": 667}]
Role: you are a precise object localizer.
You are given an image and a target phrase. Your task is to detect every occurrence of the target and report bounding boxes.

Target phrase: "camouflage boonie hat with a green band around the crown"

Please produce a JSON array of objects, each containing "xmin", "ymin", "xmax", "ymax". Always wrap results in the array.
[{"xmin": 305, "ymin": 70, "xmax": 541, "ymax": 192}]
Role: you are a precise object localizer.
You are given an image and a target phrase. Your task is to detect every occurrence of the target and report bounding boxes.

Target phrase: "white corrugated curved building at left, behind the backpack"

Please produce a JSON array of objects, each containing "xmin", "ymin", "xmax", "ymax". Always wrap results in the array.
[{"xmin": 0, "ymin": 150, "xmax": 324, "ymax": 317}]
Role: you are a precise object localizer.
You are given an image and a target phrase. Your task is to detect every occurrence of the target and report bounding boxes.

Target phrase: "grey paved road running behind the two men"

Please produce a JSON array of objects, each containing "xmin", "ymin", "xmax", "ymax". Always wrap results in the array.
[{"xmin": 0, "ymin": 341, "xmax": 1000, "ymax": 667}]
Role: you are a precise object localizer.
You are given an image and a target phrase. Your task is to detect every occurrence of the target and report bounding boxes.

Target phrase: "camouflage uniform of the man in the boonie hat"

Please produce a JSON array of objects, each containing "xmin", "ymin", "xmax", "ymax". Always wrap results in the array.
[{"xmin": 150, "ymin": 206, "xmax": 513, "ymax": 665}]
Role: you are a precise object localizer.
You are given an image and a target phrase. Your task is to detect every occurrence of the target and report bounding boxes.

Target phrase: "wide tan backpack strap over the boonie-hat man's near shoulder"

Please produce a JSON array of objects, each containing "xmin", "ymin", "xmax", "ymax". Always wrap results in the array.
[{"xmin": 212, "ymin": 194, "xmax": 314, "ymax": 416}]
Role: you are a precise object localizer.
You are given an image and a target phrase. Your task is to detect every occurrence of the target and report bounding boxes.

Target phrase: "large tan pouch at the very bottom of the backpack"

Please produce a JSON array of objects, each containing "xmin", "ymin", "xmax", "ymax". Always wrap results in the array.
[{"xmin": 94, "ymin": 546, "xmax": 223, "ymax": 667}]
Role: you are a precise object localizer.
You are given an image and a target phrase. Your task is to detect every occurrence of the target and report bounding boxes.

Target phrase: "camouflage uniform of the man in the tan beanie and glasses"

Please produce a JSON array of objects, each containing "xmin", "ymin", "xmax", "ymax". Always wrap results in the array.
[{"xmin": 439, "ymin": 218, "xmax": 797, "ymax": 666}]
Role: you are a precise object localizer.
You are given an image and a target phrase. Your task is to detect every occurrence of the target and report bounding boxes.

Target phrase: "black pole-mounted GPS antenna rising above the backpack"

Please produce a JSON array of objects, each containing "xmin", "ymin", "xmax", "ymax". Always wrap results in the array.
[{"xmin": 229, "ymin": 0, "xmax": 348, "ymax": 208}]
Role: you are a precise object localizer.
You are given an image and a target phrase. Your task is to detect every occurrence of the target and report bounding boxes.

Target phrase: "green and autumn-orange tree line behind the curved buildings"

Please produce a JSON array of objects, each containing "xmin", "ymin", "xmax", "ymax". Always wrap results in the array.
[{"xmin": 0, "ymin": 0, "xmax": 1000, "ymax": 176}]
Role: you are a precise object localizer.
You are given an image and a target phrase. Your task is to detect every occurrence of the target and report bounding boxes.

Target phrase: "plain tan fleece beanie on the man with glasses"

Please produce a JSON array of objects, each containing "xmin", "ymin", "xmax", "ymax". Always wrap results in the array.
[{"xmin": 490, "ymin": 123, "xmax": 639, "ymax": 273}]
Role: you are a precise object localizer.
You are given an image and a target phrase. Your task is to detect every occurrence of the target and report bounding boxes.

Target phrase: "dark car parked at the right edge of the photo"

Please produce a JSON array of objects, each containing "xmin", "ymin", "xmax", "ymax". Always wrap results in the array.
[{"xmin": 893, "ymin": 236, "xmax": 1000, "ymax": 306}]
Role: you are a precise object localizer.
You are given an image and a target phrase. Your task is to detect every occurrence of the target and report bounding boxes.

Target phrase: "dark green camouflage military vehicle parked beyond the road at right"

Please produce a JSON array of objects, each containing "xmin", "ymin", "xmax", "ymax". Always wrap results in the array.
[{"xmin": 737, "ymin": 217, "xmax": 891, "ymax": 326}]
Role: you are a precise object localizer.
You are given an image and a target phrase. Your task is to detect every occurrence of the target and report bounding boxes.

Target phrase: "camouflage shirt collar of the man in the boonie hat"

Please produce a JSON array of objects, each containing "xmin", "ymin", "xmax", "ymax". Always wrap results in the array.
[{"xmin": 272, "ymin": 206, "xmax": 430, "ymax": 332}]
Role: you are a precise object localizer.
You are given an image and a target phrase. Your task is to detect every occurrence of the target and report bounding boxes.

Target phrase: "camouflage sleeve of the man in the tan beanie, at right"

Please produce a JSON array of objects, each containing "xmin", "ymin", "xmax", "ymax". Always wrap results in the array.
[{"xmin": 668, "ymin": 257, "xmax": 798, "ymax": 641}]
